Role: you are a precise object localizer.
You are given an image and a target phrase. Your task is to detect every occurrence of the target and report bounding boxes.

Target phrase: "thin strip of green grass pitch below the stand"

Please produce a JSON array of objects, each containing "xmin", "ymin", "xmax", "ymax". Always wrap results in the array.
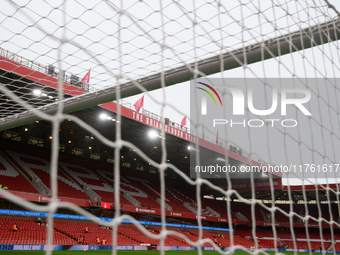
[{"xmin": 0, "ymin": 251, "xmax": 309, "ymax": 255}]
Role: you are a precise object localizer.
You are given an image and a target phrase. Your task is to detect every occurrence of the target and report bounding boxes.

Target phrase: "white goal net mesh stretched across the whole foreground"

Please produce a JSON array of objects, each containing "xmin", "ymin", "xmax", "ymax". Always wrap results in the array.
[{"xmin": 0, "ymin": 0, "xmax": 340, "ymax": 254}]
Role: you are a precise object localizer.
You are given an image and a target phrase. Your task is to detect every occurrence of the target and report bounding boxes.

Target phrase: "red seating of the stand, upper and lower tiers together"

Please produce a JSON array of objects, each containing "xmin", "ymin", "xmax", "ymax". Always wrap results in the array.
[{"xmin": 0, "ymin": 143, "xmax": 340, "ymax": 250}]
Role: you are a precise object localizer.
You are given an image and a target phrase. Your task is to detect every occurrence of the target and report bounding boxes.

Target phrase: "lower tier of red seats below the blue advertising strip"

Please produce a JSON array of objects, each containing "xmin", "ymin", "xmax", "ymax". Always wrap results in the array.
[{"xmin": 0, "ymin": 218, "xmax": 340, "ymax": 250}]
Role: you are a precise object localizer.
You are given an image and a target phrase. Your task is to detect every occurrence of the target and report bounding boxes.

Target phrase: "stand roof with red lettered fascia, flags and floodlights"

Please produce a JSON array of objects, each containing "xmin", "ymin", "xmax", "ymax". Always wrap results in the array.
[{"xmin": 0, "ymin": 49, "xmax": 282, "ymax": 174}]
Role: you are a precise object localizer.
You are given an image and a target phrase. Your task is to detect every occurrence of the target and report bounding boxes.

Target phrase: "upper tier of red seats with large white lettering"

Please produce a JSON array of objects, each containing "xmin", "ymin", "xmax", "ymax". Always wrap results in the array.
[{"xmin": 0, "ymin": 147, "xmax": 339, "ymax": 224}]
